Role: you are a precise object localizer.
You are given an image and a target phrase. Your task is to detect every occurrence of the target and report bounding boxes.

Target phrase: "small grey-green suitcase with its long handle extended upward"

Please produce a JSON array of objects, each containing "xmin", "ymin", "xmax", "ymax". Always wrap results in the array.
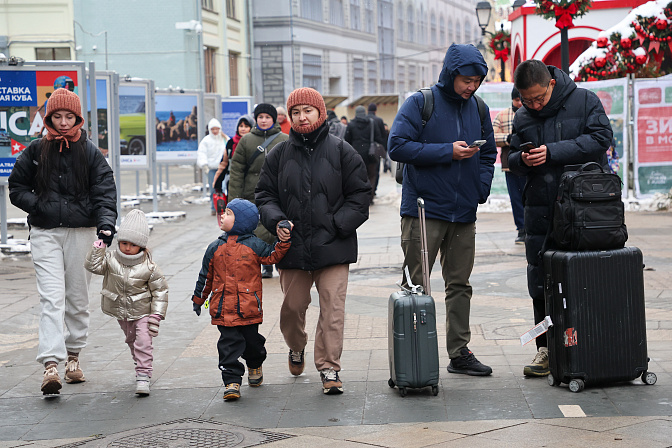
[{"xmin": 387, "ymin": 198, "xmax": 439, "ymax": 397}]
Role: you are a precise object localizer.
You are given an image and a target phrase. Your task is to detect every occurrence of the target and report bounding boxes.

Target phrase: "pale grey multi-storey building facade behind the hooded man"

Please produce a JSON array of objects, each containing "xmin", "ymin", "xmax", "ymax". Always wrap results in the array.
[{"xmin": 252, "ymin": 0, "xmax": 481, "ymax": 105}]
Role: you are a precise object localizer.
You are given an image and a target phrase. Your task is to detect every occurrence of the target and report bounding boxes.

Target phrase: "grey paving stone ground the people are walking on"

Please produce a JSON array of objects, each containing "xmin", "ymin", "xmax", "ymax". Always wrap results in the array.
[{"xmin": 0, "ymin": 170, "xmax": 672, "ymax": 448}]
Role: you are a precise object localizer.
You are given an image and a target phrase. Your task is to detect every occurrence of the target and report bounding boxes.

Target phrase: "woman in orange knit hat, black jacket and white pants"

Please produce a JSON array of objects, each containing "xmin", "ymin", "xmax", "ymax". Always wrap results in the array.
[{"xmin": 8, "ymin": 89, "xmax": 117, "ymax": 395}]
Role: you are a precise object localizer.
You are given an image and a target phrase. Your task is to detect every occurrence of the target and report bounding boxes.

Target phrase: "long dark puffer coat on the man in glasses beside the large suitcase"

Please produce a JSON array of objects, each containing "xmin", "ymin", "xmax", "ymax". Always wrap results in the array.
[{"xmin": 509, "ymin": 66, "xmax": 613, "ymax": 299}]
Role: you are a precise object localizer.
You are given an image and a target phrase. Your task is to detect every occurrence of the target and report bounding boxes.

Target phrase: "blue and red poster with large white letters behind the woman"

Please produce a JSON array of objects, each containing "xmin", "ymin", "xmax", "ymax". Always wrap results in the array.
[{"xmin": 0, "ymin": 66, "xmax": 82, "ymax": 180}]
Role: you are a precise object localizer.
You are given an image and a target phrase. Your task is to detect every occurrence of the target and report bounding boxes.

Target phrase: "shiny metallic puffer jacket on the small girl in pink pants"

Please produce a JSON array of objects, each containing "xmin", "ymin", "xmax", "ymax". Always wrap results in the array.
[{"xmin": 84, "ymin": 247, "xmax": 168, "ymax": 320}]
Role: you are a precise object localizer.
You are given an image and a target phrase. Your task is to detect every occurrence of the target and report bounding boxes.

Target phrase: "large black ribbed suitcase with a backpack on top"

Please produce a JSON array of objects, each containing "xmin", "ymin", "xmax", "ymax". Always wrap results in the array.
[{"xmin": 543, "ymin": 247, "xmax": 656, "ymax": 392}]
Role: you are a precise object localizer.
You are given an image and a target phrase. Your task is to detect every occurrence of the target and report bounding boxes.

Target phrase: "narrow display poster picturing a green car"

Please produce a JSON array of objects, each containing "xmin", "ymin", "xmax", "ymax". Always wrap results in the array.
[{"xmin": 119, "ymin": 83, "xmax": 149, "ymax": 169}]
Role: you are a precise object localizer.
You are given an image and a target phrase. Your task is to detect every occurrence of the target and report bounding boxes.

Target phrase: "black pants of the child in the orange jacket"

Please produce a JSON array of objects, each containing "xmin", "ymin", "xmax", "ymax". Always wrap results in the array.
[{"xmin": 217, "ymin": 324, "xmax": 266, "ymax": 384}]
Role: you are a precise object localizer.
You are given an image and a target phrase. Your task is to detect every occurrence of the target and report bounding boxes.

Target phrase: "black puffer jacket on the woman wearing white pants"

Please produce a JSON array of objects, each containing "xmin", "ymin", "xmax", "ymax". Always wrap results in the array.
[{"xmin": 8, "ymin": 131, "xmax": 117, "ymax": 229}]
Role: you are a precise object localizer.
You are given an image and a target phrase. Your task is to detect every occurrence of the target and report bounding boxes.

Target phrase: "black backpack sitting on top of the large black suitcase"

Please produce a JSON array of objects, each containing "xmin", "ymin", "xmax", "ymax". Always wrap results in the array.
[{"xmin": 552, "ymin": 162, "xmax": 628, "ymax": 251}]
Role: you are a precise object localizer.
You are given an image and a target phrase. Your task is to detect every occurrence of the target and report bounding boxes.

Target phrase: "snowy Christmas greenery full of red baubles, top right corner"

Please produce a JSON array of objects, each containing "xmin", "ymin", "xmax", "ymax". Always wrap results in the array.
[{"xmin": 575, "ymin": 1, "xmax": 672, "ymax": 81}]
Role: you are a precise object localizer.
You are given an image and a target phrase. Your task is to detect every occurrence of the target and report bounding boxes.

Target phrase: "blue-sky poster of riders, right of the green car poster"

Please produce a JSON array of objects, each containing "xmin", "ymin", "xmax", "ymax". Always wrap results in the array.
[{"xmin": 154, "ymin": 93, "xmax": 198, "ymax": 163}]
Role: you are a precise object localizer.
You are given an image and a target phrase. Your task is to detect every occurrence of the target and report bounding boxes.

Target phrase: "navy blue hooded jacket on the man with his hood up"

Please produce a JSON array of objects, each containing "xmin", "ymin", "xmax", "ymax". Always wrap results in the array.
[{"xmin": 388, "ymin": 44, "xmax": 497, "ymax": 223}]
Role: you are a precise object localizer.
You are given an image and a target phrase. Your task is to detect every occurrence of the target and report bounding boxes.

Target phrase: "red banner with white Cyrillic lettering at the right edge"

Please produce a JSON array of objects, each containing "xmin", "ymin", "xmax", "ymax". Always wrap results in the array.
[{"xmin": 634, "ymin": 76, "xmax": 672, "ymax": 197}]
